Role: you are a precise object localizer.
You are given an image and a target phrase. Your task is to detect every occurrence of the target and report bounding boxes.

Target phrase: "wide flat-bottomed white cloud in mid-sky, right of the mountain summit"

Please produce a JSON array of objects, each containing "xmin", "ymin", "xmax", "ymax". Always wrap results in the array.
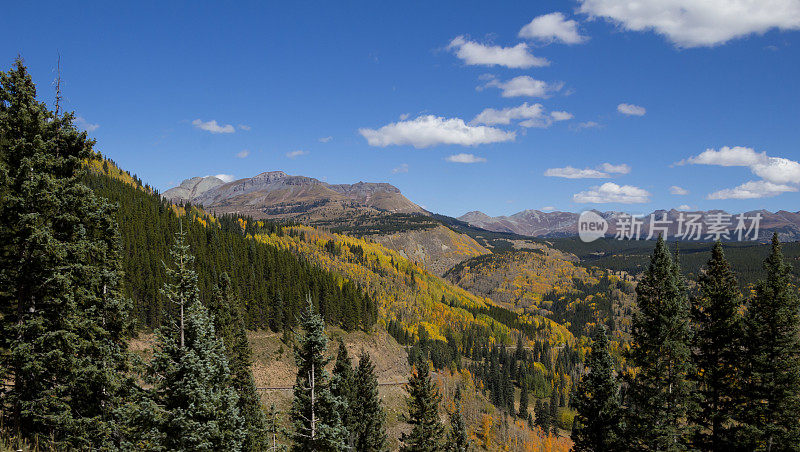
[{"xmin": 358, "ymin": 115, "xmax": 516, "ymax": 148}]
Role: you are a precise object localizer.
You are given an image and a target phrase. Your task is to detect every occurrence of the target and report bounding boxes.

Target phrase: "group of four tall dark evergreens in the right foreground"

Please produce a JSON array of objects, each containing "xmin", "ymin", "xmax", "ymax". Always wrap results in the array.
[{"xmin": 572, "ymin": 235, "xmax": 800, "ymax": 451}]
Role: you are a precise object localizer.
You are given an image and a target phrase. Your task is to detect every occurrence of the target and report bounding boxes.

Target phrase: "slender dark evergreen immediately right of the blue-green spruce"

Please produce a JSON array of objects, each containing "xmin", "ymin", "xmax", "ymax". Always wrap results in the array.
[{"xmin": 211, "ymin": 273, "xmax": 267, "ymax": 451}]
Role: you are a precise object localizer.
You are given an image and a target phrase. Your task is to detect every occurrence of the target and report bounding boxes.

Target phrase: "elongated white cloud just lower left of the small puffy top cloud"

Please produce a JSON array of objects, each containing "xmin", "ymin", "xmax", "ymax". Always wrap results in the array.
[{"xmin": 447, "ymin": 36, "xmax": 550, "ymax": 69}]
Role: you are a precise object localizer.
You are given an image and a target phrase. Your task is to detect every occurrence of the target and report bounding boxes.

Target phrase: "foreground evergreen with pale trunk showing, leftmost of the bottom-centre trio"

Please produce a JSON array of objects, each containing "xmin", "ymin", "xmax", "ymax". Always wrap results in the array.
[{"xmin": 291, "ymin": 297, "xmax": 347, "ymax": 451}]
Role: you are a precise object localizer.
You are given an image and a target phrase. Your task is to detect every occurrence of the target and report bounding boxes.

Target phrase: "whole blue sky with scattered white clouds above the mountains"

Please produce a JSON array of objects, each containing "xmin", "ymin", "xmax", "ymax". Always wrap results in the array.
[{"xmin": 0, "ymin": 0, "xmax": 800, "ymax": 216}]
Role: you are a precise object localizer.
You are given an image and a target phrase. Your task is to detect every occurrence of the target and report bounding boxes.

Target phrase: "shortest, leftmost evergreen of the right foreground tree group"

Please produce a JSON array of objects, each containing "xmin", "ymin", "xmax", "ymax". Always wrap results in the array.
[{"xmin": 572, "ymin": 326, "xmax": 621, "ymax": 452}]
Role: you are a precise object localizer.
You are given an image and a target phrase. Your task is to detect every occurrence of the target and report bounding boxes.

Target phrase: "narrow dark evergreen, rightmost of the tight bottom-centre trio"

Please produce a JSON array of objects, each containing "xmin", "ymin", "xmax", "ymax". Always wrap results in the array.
[{"xmin": 352, "ymin": 350, "xmax": 386, "ymax": 452}]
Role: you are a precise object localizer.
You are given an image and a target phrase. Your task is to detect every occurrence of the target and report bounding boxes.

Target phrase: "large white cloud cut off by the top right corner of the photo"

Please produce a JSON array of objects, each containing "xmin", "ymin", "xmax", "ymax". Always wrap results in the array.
[{"xmin": 579, "ymin": 0, "xmax": 800, "ymax": 47}]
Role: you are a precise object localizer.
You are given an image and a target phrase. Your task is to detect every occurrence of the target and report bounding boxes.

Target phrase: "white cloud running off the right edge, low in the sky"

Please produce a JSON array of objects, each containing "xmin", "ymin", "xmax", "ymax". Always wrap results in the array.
[{"xmin": 676, "ymin": 146, "xmax": 800, "ymax": 184}]
